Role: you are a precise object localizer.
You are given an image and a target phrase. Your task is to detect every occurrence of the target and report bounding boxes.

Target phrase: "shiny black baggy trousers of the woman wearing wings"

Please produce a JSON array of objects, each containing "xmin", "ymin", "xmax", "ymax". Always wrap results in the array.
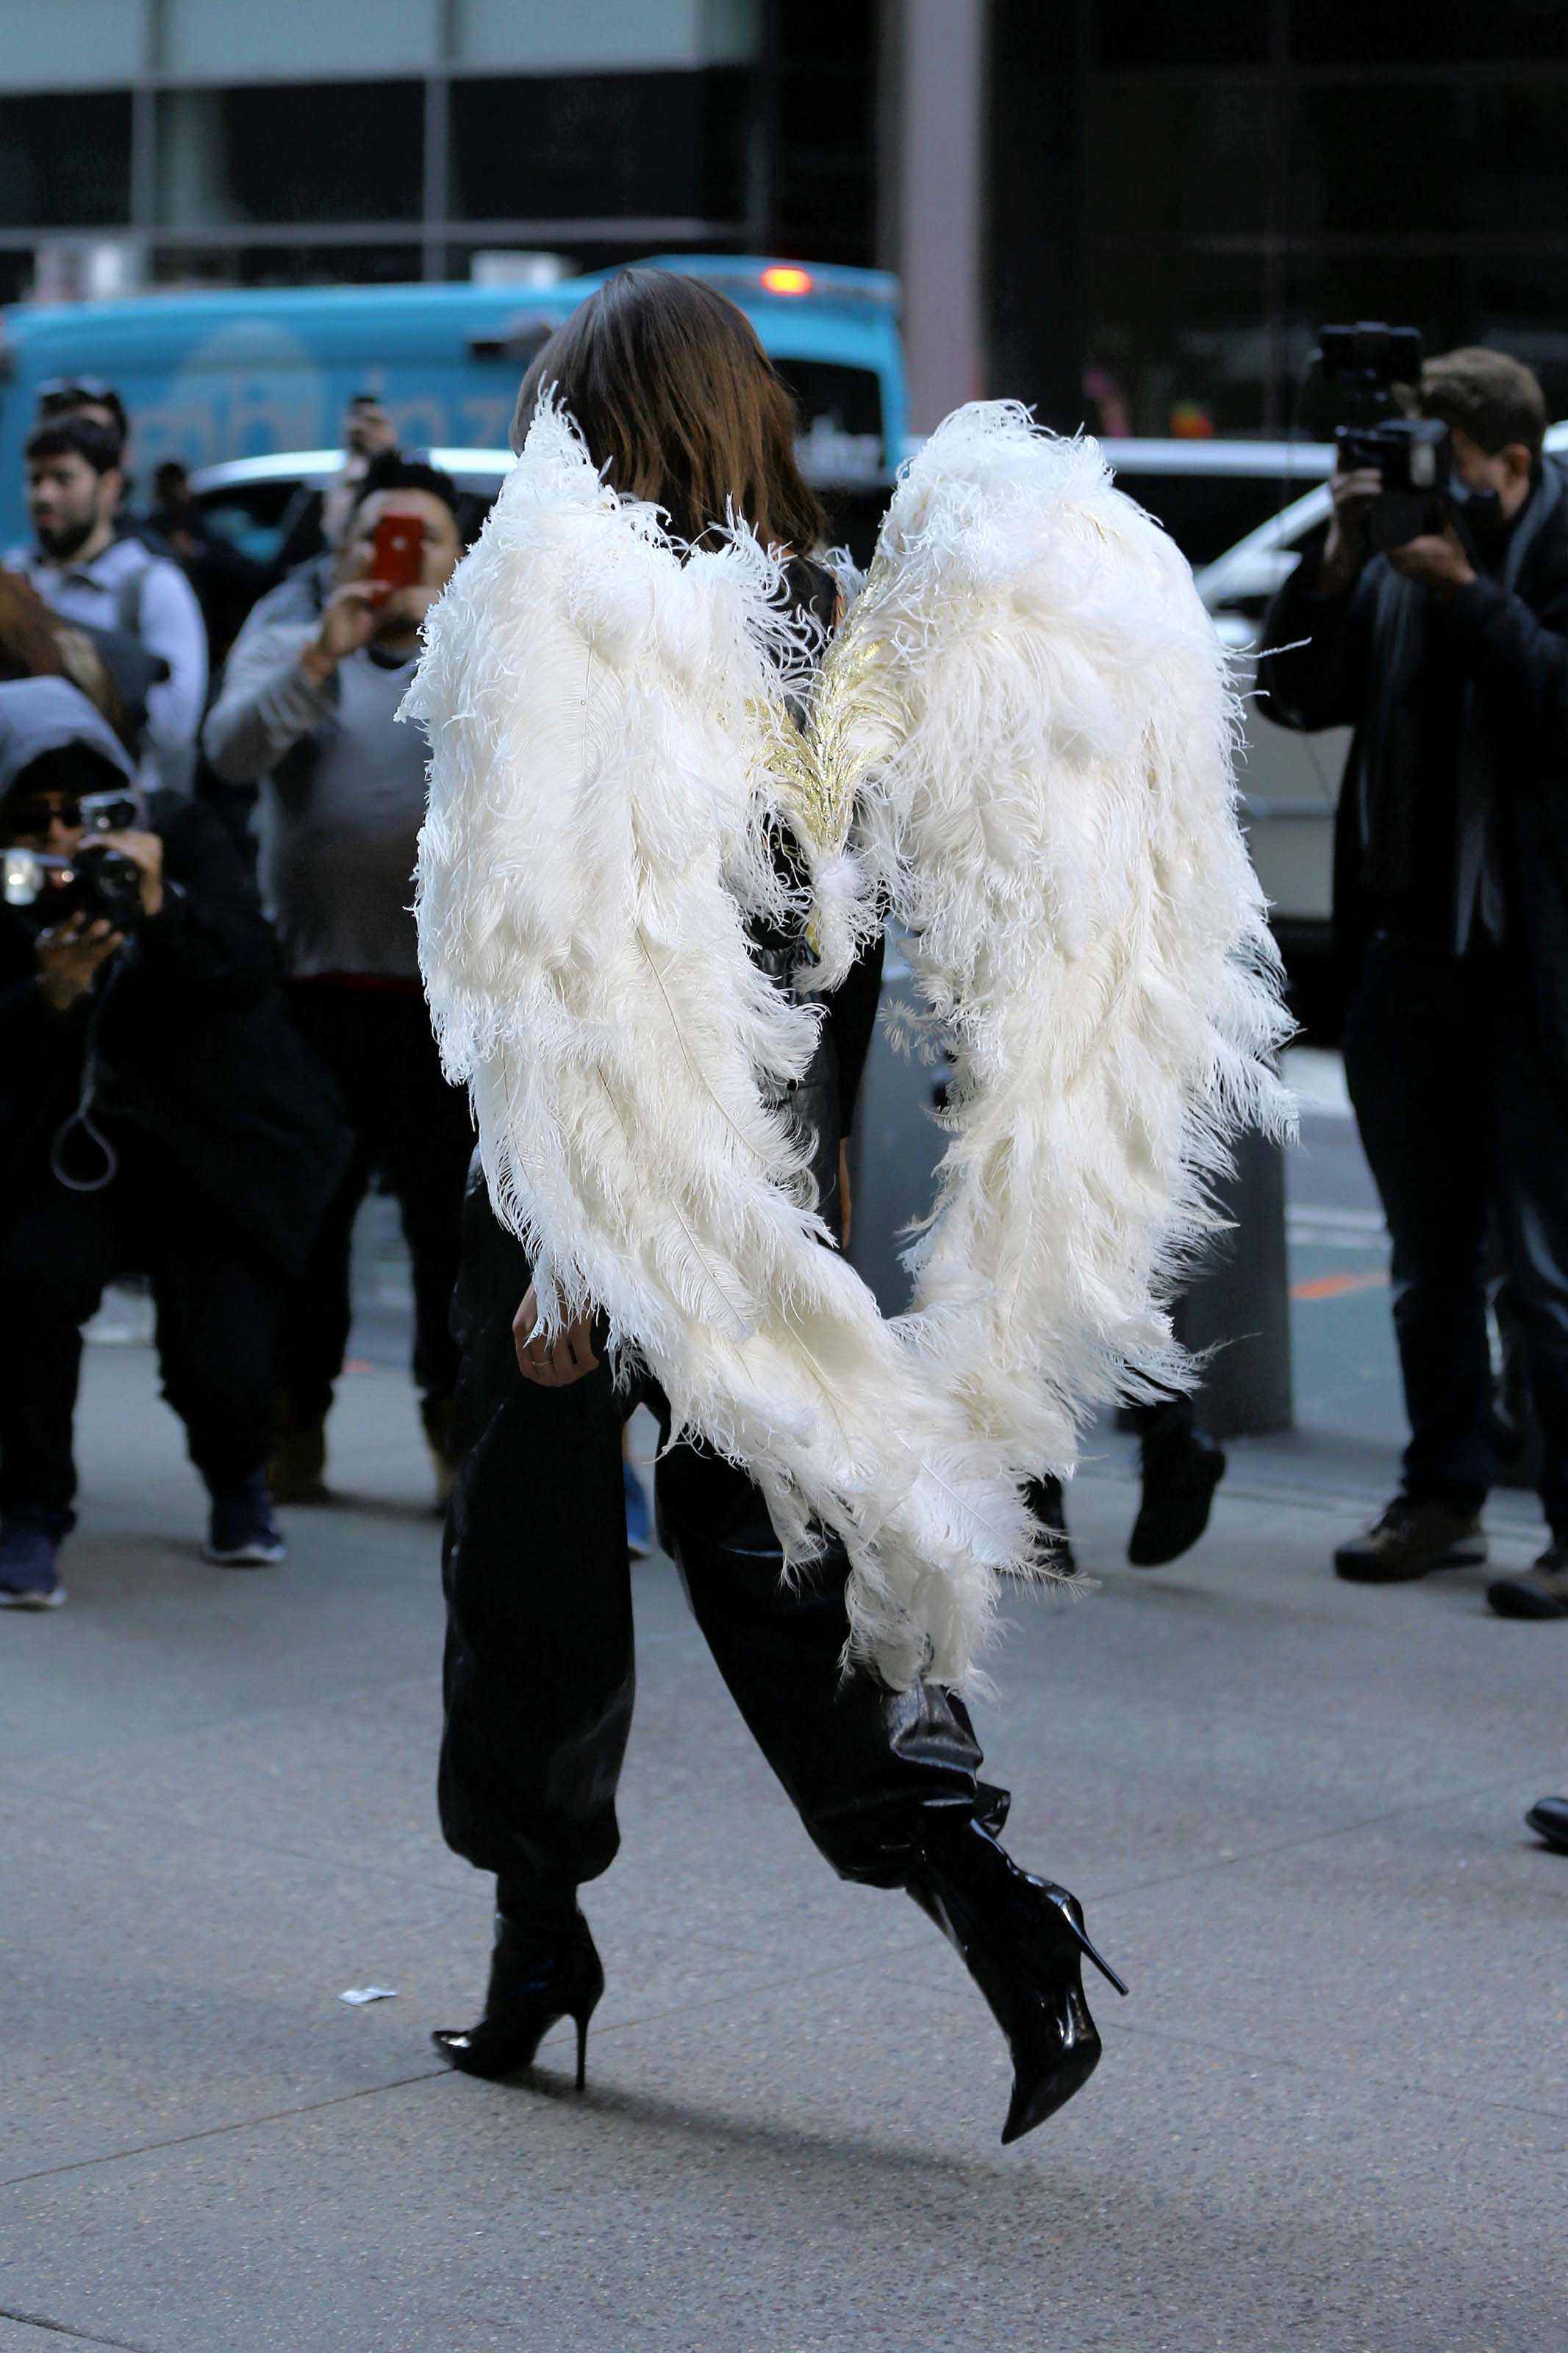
[{"xmin": 440, "ymin": 1181, "xmax": 1006, "ymax": 1887}]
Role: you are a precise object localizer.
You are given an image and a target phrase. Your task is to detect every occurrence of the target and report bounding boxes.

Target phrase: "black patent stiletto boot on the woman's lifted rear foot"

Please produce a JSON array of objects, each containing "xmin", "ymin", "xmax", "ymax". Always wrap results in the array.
[{"xmin": 907, "ymin": 1807, "xmax": 1126, "ymax": 2141}]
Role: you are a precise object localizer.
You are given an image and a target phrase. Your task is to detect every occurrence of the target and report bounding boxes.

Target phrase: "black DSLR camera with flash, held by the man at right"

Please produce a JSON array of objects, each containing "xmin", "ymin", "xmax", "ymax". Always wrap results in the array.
[{"xmin": 1311, "ymin": 320, "xmax": 1464, "ymax": 549}]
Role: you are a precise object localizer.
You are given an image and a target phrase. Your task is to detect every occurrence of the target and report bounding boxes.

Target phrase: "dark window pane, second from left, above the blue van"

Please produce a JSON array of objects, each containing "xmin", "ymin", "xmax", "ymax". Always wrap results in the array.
[{"xmin": 157, "ymin": 82, "xmax": 426, "ymax": 228}]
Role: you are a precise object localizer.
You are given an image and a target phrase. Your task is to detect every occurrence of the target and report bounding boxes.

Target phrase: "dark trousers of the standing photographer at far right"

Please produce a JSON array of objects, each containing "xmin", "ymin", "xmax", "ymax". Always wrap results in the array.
[{"xmin": 1345, "ymin": 932, "xmax": 1568, "ymax": 1543}]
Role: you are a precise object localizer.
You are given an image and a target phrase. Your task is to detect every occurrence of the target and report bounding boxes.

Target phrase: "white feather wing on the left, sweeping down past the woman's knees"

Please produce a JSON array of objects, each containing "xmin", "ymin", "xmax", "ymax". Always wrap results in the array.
[{"xmin": 404, "ymin": 407, "xmax": 1032, "ymax": 1685}]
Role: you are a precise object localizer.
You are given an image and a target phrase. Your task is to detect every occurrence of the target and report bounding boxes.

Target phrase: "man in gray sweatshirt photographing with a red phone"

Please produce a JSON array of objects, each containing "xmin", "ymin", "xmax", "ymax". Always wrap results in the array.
[{"xmin": 202, "ymin": 454, "xmax": 473, "ymax": 1502}]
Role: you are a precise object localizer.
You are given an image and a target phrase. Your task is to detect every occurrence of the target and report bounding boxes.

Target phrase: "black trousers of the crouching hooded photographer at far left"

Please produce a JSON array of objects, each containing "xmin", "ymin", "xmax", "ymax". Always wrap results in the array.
[{"xmin": 0, "ymin": 1134, "xmax": 284, "ymax": 1532}]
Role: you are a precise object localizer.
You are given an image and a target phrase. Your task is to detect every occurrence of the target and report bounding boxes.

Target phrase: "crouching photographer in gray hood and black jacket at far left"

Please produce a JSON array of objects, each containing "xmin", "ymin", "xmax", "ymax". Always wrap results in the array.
[{"xmin": 0, "ymin": 678, "xmax": 346, "ymax": 1607}]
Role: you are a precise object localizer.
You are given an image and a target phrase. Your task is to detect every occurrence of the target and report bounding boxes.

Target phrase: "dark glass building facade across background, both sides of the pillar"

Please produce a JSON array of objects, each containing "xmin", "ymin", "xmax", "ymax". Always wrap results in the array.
[{"xmin": 0, "ymin": 0, "xmax": 1568, "ymax": 435}]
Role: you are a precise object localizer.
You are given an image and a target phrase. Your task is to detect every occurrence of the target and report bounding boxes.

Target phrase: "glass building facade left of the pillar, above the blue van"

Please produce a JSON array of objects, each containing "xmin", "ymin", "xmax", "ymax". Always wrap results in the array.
[{"xmin": 0, "ymin": 0, "xmax": 875, "ymax": 299}]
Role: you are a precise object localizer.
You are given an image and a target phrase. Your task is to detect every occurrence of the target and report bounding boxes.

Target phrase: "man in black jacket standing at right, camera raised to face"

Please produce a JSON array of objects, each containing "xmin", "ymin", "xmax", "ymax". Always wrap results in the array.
[{"xmin": 1260, "ymin": 351, "xmax": 1568, "ymax": 1616}]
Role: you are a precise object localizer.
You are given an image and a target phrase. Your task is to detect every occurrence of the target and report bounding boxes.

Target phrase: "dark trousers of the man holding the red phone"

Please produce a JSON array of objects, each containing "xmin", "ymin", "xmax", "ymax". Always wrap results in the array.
[{"xmin": 277, "ymin": 981, "xmax": 473, "ymax": 1424}]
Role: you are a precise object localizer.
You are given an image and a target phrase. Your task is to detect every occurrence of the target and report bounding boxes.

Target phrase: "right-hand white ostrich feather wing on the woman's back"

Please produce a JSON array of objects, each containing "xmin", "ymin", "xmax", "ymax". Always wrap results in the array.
[{"xmin": 811, "ymin": 402, "xmax": 1291, "ymax": 1473}]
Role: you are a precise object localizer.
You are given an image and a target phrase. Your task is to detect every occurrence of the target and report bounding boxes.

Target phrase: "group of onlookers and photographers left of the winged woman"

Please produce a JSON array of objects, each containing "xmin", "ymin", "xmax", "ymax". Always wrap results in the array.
[{"xmin": 0, "ymin": 381, "xmax": 491, "ymax": 1607}]
